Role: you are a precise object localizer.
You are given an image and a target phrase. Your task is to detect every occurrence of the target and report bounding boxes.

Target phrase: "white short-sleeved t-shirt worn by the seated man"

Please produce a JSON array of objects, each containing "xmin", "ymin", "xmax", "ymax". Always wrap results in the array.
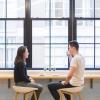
[{"xmin": 70, "ymin": 54, "xmax": 85, "ymax": 86}]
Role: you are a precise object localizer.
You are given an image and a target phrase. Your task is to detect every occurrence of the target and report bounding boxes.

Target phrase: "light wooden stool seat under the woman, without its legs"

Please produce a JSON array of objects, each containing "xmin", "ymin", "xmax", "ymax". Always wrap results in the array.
[{"xmin": 13, "ymin": 86, "xmax": 38, "ymax": 93}]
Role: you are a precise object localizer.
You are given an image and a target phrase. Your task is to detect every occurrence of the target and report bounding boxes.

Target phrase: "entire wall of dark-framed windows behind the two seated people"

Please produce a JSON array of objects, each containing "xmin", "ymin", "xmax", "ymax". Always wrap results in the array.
[{"xmin": 0, "ymin": 0, "xmax": 100, "ymax": 69}]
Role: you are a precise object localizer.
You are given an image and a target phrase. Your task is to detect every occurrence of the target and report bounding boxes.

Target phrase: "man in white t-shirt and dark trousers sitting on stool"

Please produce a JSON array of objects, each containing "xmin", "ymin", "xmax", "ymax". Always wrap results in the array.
[{"xmin": 48, "ymin": 41, "xmax": 85, "ymax": 100}]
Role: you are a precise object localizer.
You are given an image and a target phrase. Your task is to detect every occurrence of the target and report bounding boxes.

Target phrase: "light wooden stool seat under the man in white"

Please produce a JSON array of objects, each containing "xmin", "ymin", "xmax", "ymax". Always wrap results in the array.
[{"xmin": 60, "ymin": 86, "xmax": 84, "ymax": 93}]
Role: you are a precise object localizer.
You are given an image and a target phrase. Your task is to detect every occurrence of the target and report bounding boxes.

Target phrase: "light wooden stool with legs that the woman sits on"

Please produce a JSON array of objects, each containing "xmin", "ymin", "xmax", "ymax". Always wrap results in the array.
[{"xmin": 13, "ymin": 86, "xmax": 38, "ymax": 100}]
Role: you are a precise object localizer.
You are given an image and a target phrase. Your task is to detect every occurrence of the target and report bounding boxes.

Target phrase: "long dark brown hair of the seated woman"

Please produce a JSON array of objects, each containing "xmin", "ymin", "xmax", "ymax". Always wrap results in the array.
[{"xmin": 14, "ymin": 46, "xmax": 27, "ymax": 64}]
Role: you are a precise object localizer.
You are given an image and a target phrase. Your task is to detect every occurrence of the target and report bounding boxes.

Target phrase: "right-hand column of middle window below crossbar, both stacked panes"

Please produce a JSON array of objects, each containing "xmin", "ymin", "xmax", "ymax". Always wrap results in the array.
[{"xmin": 50, "ymin": 20, "xmax": 68, "ymax": 68}]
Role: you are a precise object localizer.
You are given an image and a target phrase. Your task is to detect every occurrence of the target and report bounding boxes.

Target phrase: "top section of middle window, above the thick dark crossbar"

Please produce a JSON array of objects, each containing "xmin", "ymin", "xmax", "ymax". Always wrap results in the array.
[{"xmin": 31, "ymin": 0, "xmax": 69, "ymax": 18}]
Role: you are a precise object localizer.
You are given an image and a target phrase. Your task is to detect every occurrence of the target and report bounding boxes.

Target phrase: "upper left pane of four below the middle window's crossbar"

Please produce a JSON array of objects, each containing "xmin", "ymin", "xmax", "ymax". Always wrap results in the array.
[{"xmin": 32, "ymin": 21, "xmax": 49, "ymax": 43}]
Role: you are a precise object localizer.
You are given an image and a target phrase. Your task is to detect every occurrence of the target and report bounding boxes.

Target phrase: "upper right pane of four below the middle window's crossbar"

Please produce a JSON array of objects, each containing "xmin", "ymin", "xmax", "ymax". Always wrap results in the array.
[{"xmin": 51, "ymin": 20, "xmax": 68, "ymax": 43}]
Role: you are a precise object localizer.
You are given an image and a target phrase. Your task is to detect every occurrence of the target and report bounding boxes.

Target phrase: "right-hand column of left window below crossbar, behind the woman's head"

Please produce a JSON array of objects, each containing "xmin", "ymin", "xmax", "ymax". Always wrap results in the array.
[{"xmin": 5, "ymin": 20, "xmax": 23, "ymax": 68}]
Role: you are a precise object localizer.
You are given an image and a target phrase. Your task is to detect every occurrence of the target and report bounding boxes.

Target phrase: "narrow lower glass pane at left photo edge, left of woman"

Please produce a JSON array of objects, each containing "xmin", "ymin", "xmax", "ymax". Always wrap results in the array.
[{"xmin": 0, "ymin": 44, "xmax": 5, "ymax": 68}]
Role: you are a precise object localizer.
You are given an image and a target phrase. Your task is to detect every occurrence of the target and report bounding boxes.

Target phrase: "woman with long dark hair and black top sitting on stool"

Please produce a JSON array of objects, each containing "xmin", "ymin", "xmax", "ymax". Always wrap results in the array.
[{"xmin": 14, "ymin": 46, "xmax": 42, "ymax": 100}]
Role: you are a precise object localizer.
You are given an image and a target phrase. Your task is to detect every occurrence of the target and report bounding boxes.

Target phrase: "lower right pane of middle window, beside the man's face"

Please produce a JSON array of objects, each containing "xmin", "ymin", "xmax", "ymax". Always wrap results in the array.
[{"xmin": 51, "ymin": 44, "xmax": 68, "ymax": 68}]
